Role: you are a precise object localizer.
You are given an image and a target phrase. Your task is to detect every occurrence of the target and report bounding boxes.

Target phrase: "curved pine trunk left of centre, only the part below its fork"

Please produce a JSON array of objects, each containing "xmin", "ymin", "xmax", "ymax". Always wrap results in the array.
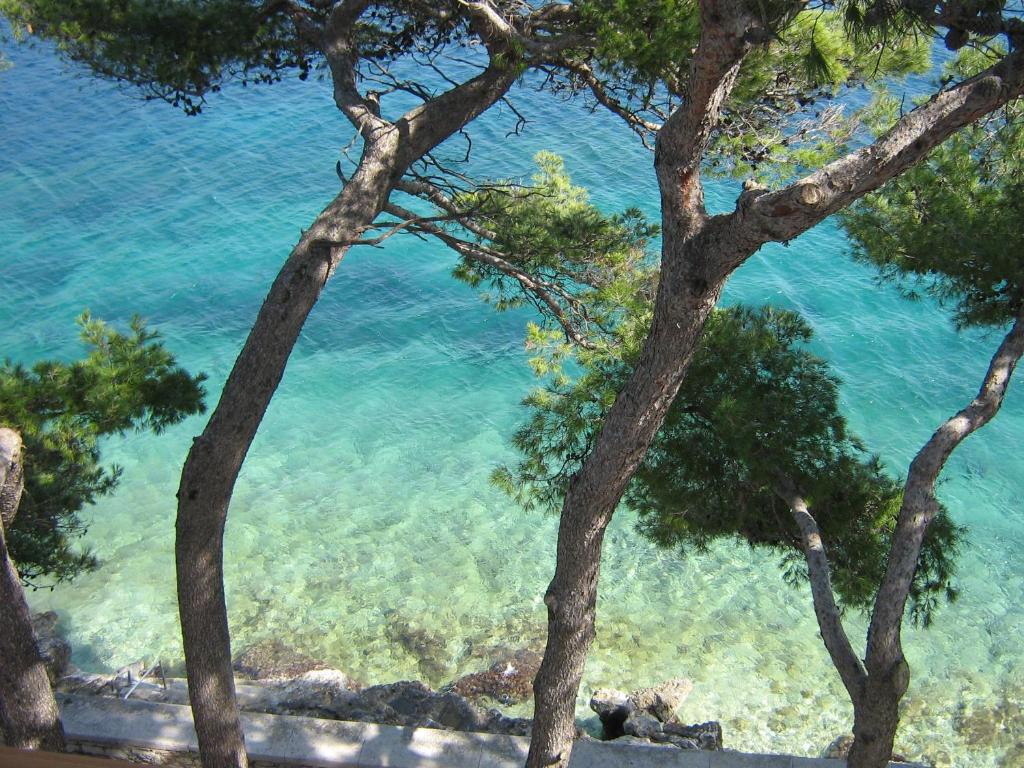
[{"xmin": 175, "ymin": 140, "xmax": 396, "ymax": 768}]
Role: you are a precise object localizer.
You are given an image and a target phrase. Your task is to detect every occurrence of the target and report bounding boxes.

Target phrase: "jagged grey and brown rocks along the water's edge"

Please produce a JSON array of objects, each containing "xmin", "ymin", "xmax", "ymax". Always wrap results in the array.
[{"xmin": 33, "ymin": 612, "xmax": 722, "ymax": 750}]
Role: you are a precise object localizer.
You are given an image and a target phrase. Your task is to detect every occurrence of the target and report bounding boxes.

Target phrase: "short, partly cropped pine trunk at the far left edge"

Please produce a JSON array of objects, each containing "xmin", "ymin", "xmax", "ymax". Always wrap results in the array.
[{"xmin": 0, "ymin": 428, "xmax": 65, "ymax": 752}]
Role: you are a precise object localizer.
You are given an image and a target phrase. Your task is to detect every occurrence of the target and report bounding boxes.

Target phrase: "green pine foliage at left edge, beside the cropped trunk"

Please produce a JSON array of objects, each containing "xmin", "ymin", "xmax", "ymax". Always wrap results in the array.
[{"xmin": 0, "ymin": 313, "xmax": 205, "ymax": 586}]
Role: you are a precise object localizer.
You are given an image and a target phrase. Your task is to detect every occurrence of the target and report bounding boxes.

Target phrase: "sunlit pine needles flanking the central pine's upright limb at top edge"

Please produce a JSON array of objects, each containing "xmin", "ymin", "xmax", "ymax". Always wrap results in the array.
[{"xmin": 577, "ymin": 0, "xmax": 931, "ymax": 180}]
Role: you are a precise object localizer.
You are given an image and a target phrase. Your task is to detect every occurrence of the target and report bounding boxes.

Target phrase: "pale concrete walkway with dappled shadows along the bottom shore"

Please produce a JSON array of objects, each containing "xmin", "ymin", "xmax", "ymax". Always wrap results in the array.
[{"xmin": 61, "ymin": 696, "xmax": 917, "ymax": 768}]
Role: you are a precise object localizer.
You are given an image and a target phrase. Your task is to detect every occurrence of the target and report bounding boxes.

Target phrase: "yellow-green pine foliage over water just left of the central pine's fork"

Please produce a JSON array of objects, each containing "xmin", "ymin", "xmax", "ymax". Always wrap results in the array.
[{"xmin": 455, "ymin": 153, "xmax": 657, "ymax": 358}]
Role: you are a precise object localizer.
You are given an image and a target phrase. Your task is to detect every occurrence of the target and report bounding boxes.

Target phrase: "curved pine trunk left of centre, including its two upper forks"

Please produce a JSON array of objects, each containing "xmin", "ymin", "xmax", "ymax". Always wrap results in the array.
[{"xmin": 175, "ymin": 2, "xmax": 515, "ymax": 768}]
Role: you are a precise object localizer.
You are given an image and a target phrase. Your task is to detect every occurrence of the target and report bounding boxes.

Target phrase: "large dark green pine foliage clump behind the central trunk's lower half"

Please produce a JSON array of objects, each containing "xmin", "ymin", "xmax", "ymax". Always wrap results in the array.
[{"xmin": 494, "ymin": 307, "xmax": 964, "ymax": 624}]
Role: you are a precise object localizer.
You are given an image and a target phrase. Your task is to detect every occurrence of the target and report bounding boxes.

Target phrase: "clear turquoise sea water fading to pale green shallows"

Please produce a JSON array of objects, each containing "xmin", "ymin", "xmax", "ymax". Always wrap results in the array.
[{"xmin": 0, "ymin": 40, "xmax": 1024, "ymax": 767}]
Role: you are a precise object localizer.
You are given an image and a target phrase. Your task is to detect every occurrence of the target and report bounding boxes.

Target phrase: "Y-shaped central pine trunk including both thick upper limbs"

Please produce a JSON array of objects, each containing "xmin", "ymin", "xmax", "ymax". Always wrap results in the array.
[{"xmin": 527, "ymin": 9, "xmax": 1024, "ymax": 768}]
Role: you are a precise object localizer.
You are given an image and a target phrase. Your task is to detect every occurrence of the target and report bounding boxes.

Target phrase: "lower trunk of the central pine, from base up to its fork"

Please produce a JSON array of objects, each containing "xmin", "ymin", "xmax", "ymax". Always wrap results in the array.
[{"xmin": 526, "ymin": 219, "xmax": 726, "ymax": 768}]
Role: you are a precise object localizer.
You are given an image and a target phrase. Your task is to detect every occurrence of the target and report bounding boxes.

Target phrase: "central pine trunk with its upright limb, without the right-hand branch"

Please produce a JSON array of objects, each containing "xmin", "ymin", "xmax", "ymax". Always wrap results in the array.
[{"xmin": 526, "ymin": 2, "xmax": 748, "ymax": 768}]
